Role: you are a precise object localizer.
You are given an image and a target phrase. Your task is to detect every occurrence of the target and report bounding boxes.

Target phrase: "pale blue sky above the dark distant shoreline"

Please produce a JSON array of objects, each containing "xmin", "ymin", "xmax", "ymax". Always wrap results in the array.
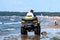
[{"xmin": 0, "ymin": 0, "xmax": 60, "ymax": 12}]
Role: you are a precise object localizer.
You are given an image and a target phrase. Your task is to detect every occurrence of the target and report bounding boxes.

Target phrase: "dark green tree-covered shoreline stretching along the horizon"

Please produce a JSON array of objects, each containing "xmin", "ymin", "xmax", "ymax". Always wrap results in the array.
[{"xmin": 0, "ymin": 11, "xmax": 60, "ymax": 16}]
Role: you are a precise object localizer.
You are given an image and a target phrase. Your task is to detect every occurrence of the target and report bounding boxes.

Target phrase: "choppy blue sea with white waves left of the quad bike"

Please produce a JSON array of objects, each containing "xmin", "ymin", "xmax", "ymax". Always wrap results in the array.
[{"xmin": 0, "ymin": 16, "xmax": 21, "ymax": 35}]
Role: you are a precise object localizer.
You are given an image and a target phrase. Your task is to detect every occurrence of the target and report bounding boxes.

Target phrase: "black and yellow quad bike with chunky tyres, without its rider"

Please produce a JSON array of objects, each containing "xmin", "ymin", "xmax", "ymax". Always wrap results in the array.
[{"xmin": 21, "ymin": 16, "xmax": 41, "ymax": 35}]
